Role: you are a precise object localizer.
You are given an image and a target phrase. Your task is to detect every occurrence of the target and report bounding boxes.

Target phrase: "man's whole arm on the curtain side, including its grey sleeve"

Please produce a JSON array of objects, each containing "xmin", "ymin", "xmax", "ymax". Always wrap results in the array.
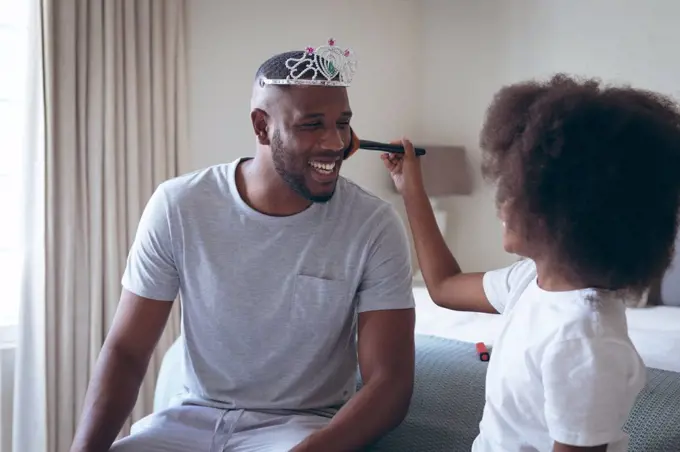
[{"xmin": 71, "ymin": 185, "xmax": 179, "ymax": 452}]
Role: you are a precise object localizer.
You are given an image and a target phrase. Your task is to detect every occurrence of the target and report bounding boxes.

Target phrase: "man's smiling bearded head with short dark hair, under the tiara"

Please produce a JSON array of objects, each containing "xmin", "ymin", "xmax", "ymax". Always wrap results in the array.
[{"xmin": 251, "ymin": 51, "xmax": 352, "ymax": 202}]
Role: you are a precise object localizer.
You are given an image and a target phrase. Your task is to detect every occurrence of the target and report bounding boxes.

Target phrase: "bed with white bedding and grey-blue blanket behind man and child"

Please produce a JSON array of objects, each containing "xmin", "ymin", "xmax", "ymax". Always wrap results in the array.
[{"xmin": 154, "ymin": 251, "xmax": 680, "ymax": 452}]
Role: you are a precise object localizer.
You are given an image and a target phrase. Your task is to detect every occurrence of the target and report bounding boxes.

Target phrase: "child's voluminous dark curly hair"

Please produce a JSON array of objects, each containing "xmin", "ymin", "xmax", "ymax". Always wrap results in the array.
[{"xmin": 480, "ymin": 74, "xmax": 680, "ymax": 293}]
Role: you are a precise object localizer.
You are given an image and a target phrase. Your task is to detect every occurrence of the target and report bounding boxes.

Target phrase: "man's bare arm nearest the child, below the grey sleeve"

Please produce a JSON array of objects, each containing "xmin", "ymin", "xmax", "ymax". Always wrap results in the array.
[{"xmin": 293, "ymin": 309, "xmax": 415, "ymax": 452}]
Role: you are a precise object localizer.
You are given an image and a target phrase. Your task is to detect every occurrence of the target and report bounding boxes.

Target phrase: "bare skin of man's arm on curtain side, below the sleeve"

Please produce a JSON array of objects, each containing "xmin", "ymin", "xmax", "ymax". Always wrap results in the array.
[{"xmin": 71, "ymin": 290, "xmax": 172, "ymax": 452}]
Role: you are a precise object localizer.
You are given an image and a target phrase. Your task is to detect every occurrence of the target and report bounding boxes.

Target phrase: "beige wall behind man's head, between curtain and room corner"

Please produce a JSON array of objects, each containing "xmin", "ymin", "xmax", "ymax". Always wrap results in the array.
[{"xmin": 183, "ymin": 0, "xmax": 422, "ymax": 199}]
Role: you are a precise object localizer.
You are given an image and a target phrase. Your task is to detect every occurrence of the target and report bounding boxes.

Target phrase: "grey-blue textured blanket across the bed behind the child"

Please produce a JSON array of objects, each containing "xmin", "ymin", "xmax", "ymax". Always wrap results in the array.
[{"xmin": 359, "ymin": 336, "xmax": 680, "ymax": 452}]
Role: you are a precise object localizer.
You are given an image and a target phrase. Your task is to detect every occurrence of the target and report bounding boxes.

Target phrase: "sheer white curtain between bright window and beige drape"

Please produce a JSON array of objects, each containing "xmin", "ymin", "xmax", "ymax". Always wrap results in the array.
[{"xmin": 12, "ymin": 1, "xmax": 47, "ymax": 452}]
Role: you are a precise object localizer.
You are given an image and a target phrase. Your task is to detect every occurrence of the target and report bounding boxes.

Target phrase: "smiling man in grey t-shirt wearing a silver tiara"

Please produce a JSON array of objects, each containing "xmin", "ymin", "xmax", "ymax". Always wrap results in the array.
[{"xmin": 71, "ymin": 41, "xmax": 414, "ymax": 452}]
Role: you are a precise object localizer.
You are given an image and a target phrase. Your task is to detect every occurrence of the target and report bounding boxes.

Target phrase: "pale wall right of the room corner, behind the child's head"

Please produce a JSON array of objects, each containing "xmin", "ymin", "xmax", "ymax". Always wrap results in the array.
[{"xmin": 421, "ymin": 0, "xmax": 680, "ymax": 270}]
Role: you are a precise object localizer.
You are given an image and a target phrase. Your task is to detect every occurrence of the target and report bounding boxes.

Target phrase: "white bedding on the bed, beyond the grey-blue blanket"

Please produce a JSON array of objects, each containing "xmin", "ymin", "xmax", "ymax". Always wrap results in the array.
[{"xmin": 413, "ymin": 287, "xmax": 680, "ymax": 372}]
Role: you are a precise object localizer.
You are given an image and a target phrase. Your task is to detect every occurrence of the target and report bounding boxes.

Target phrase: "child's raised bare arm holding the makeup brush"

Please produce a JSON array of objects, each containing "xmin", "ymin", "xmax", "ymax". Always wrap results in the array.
[{"xmin": 382, "ymin": 139, "xmax": 498, "ymax": 314}]
